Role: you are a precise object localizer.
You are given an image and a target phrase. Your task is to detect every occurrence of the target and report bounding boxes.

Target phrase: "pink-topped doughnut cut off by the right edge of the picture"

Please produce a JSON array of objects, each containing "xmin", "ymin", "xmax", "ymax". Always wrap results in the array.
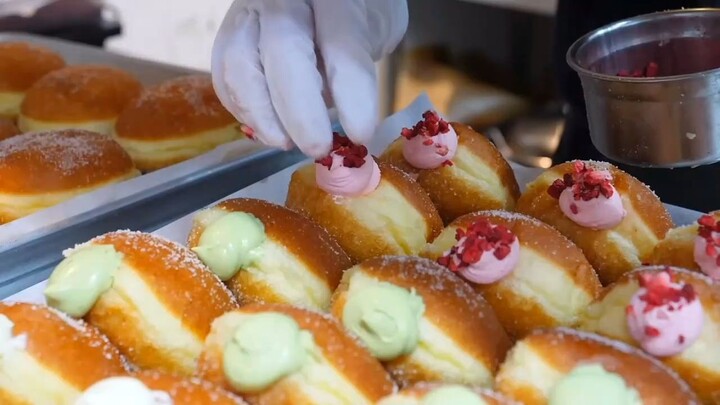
[{"xmin": 649, "ymin": 211, "xmax": 720, "ymax": 281}]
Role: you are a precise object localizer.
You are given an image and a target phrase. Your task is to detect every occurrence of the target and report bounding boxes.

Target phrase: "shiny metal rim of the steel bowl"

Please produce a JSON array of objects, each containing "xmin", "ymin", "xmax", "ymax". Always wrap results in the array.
[{"xmin": 565, "ymin": 7, "xmax": 720, "ymax": 83}]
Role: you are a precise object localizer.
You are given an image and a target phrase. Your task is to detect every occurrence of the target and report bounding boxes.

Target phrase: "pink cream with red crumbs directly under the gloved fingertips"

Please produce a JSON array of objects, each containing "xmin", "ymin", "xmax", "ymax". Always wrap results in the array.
[{"xmin": 315, "ymin": 133, "xmax": 380, "ymax": 197}]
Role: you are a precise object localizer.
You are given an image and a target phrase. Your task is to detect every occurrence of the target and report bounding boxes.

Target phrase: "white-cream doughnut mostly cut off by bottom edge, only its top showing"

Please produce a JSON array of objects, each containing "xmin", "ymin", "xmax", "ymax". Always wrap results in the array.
[{"xmin": 74, "ymin": 371, "xmax": 245, "ymax": 405}]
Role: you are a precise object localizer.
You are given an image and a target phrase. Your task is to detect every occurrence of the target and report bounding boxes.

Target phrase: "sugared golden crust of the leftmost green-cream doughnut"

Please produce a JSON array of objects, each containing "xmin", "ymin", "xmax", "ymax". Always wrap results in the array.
[{"xmin": 85, "ymin": 231, "xmax": 237, "ymax": 372}]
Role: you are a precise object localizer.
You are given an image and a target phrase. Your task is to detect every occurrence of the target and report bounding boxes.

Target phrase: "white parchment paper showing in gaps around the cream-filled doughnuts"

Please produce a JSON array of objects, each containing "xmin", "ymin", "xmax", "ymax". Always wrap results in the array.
[{"xmin": 7, "ymin": 94, "xmax": 701, "ymax": 303}]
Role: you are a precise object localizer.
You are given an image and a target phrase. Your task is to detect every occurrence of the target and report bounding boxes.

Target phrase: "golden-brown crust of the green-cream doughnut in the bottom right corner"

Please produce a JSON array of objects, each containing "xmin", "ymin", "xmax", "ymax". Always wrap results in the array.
[{"xmin": 496, "ymin": 328, "xmax": 697, "ymax": 405}]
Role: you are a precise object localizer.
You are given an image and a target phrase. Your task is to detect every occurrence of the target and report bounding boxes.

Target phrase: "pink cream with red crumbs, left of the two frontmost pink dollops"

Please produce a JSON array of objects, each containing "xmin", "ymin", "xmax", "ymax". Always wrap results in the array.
[{"xmin": 438, "ymin": 220, "xmax": 520, "ymax": 284}]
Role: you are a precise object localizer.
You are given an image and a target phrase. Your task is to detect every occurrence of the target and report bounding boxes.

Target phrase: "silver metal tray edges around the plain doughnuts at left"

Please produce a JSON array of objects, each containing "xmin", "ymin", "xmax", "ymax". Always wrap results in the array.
[{"xmin": 0, "ymin": 33, "xmax": 303, "ymax": 286}]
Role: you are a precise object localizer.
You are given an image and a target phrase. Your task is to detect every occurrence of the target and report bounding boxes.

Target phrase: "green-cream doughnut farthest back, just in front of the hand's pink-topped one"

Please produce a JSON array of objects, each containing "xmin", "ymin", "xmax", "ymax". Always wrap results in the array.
[{"xmin": 188, "ymin": 198, "xmax": 352, "ymax": 310}]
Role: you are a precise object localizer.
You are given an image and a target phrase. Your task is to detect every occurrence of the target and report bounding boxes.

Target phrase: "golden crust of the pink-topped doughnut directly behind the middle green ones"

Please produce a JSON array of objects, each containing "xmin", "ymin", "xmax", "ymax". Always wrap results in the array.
[{"xmin": 423, "ymin": 211, "xmax": 602, "ymax": 338}]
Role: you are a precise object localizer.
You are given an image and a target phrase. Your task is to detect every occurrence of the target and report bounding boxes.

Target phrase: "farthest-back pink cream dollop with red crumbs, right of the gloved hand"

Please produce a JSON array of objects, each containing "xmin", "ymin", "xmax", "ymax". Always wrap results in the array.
[{"xmin": 401, "ymin": 111, "xmax": 458, "ymax": 169}]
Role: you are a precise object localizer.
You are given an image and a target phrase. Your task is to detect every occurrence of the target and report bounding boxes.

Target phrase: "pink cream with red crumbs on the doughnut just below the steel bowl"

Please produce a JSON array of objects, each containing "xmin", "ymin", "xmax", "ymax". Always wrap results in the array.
[{"xmin": 548, "ymin": 162, "xmax": 627, "ymax": 229}]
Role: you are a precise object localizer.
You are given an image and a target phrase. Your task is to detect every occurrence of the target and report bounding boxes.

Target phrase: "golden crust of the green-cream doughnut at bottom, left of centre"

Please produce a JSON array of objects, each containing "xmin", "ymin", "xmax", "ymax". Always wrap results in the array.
[{"xmin": 198, "ymin": 304, "xmax": 394, "ymax": 405}]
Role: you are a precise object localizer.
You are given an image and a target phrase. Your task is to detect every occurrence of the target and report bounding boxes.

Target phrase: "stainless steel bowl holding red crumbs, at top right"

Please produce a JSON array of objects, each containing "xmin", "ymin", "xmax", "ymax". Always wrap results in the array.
[{"xmin": 567, "ymin": 9, "xmax": 720, "ymax": 167}]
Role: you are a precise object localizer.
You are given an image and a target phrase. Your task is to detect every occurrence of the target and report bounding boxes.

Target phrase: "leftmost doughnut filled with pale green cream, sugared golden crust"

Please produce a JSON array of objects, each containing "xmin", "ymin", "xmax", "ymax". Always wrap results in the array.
[{"xmin": 44, "ymin": 231, "xmax": 237, "ymax": 375}]
